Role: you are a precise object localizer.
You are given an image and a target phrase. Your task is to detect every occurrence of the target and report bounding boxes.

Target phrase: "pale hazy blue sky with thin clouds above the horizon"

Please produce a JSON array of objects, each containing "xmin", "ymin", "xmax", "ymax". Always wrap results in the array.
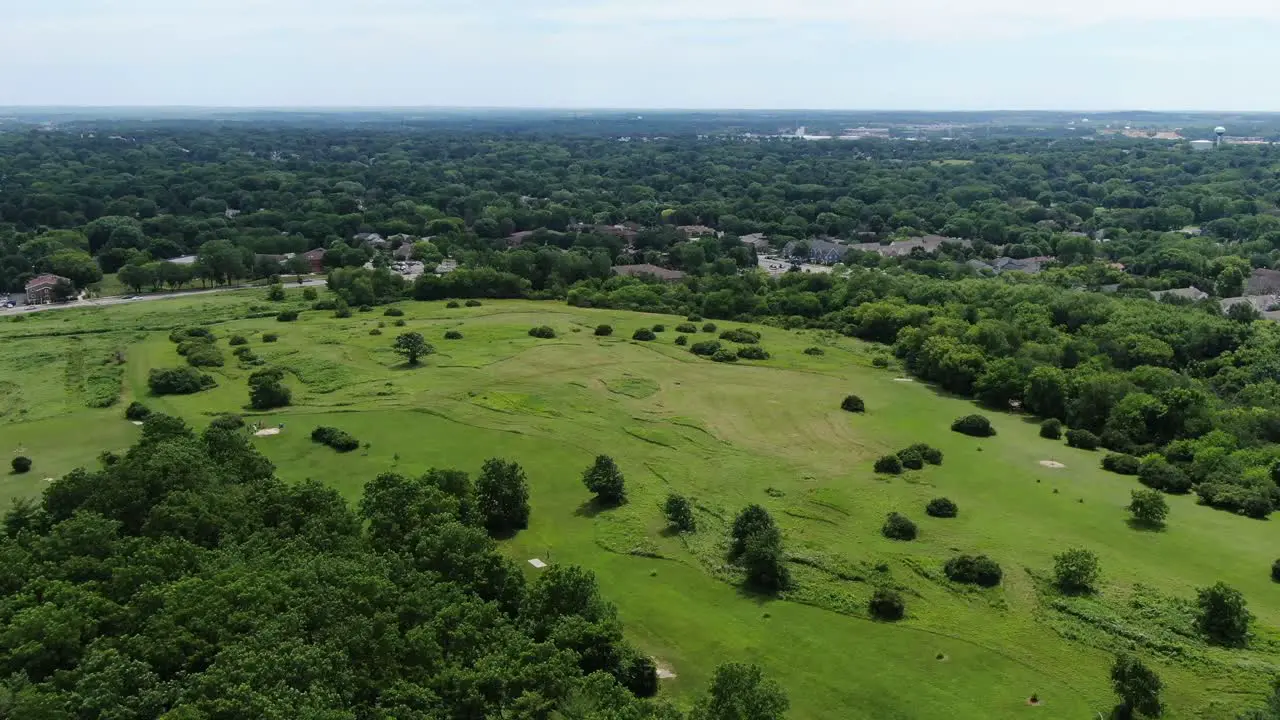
[{"xmin": 0, "ymin": 0, "xmax": 1280, "ymax": 110}]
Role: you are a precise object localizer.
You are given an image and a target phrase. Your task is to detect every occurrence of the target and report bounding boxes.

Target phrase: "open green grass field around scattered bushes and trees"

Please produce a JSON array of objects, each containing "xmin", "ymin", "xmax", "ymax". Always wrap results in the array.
[{"xmin": 0, "ymin": 291, "xmax": 1280, "ymax": 719}]
